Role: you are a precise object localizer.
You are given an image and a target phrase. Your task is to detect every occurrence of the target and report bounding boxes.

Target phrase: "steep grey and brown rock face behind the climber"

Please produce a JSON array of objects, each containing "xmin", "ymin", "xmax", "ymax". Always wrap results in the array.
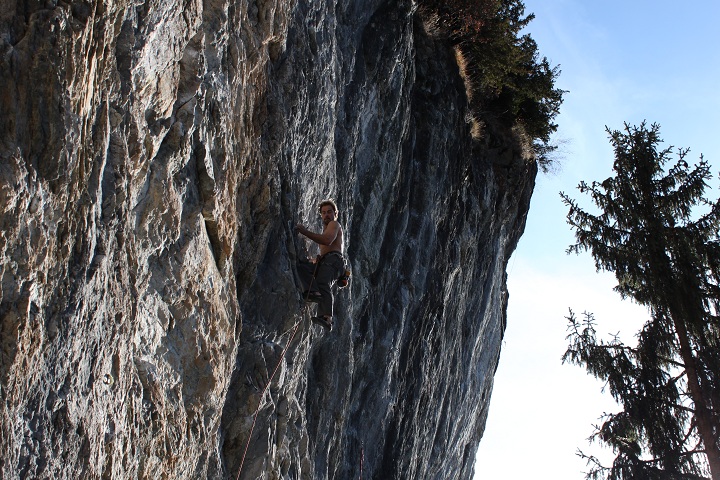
[{"xmin": 0, "ymin": 0, "xmax": 535, "ymax": 479}]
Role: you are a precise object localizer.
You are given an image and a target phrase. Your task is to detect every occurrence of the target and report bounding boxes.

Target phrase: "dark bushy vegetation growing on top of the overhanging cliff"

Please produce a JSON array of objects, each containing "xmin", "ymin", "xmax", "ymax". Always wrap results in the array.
[{"xmin": 419, "ymin": 0, "xmax": 565, "ymax": 170}]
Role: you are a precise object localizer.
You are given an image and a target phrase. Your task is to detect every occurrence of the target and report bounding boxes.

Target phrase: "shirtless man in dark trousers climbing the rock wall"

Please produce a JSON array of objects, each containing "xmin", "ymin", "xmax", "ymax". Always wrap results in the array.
[{"xmin": 295, "ymin": 200, "xmax": 345, "ymax": 330}]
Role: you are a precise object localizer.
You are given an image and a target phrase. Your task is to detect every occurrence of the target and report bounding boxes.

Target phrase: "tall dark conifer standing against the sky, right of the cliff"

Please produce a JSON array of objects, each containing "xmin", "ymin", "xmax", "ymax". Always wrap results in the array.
[{"xmin": 561, "ymin": 123, "xmax": 720, "ymax": 480}]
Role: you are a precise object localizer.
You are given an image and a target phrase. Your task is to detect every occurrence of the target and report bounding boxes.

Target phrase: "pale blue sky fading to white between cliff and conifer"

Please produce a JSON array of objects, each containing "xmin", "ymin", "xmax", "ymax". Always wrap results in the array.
[{"xmin": 475, "ymin": 0, "xmax": 720, "ymax": 480}]
